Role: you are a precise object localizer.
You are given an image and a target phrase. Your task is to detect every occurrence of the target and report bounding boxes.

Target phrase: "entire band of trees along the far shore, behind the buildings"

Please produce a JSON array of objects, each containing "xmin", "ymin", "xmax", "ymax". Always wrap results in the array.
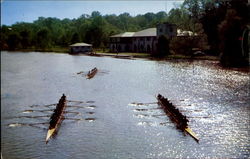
[{"xmin": 1, "ymin": 0, "xmax": 250, "ymax": 65}]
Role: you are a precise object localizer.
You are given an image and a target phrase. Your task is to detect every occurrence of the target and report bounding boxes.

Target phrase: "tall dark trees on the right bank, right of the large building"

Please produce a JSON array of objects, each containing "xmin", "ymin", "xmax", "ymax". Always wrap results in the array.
[{"xmin": 168, "ymin": 0, "xmax": 250, "ymax": 66}]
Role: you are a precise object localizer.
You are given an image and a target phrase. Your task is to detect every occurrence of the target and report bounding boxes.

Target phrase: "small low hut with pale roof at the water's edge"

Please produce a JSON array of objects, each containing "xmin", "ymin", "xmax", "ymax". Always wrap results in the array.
[{"xmin": 70, "ymin": 43, "xmax": 92, "ymax": 54}]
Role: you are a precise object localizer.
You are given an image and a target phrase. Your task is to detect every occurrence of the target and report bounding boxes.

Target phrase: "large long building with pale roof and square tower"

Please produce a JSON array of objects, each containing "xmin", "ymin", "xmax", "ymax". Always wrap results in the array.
[{"xmin": 110, "ymin": 23, "xmax": 177, "ymax": 54}]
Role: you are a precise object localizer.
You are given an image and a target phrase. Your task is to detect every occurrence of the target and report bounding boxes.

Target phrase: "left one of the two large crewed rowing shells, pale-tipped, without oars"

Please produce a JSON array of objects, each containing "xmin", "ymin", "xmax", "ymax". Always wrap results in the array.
[{"xmin": 45, "ymin": 94, "xmax": 66, "ymax": 143}]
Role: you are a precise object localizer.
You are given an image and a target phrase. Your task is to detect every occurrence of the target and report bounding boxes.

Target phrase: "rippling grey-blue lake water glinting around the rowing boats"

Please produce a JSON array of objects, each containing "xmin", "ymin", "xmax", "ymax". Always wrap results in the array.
[{"xmin": 1, "ymin": 52, "xmax": 250, "ymax": 159}]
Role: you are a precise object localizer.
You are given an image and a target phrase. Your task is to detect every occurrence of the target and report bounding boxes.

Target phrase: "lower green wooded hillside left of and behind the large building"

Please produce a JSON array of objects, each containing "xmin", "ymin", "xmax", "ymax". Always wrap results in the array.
[{"xmin": 1, "ymin": 11, "xmax": 167, "ymax": 50}]
